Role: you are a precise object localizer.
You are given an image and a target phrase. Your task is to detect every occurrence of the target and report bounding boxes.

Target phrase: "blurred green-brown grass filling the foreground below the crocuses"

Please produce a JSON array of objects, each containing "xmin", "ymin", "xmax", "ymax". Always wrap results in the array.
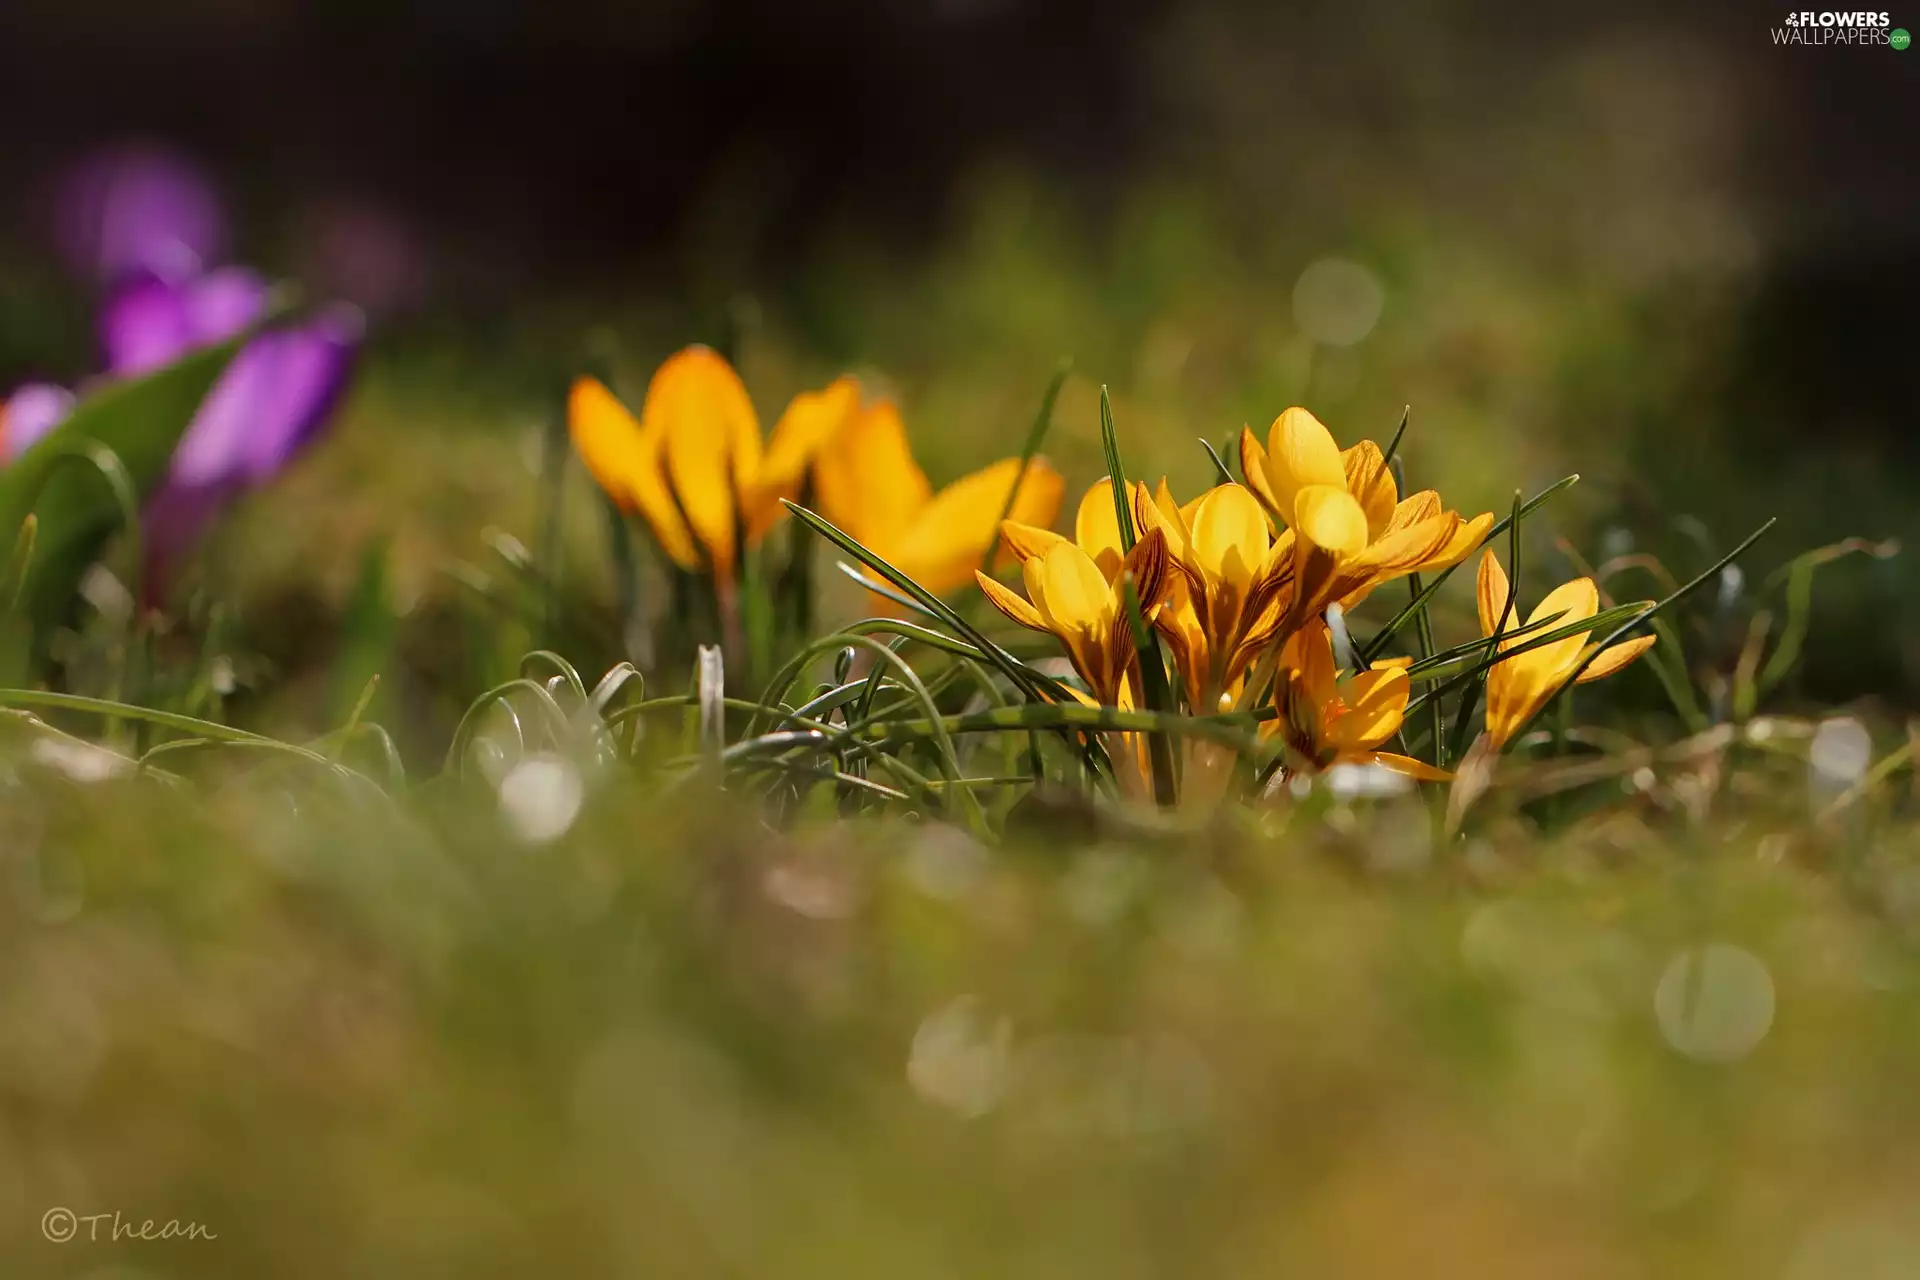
[{"xmin": 0, "ymin": 764, "xmax": 1920, "ymax": 1280}]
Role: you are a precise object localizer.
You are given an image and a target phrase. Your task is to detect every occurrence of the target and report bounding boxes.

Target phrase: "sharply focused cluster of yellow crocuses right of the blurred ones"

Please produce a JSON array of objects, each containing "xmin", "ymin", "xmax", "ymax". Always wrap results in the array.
[{"xmin": 975, "ymin": 409, "xmax": 1653, "ymax": 779}]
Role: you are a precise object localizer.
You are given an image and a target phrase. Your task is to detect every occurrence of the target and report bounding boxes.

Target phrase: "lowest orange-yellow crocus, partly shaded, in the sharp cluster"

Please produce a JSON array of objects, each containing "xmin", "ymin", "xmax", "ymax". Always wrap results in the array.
[{"xmin": 1267, "ymin": 620, "xmax": 1452, "ymax": 781}]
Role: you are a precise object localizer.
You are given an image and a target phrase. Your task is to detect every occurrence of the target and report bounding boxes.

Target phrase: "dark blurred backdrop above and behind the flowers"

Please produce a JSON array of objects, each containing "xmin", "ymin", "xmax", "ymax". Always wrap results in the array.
[{"xmin": 0, "ymin": 0, "xmax": 1920, "ymax": 721}]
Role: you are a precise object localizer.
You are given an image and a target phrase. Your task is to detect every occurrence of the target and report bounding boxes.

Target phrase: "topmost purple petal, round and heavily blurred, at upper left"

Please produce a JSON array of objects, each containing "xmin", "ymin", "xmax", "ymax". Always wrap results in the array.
[{"xmin": 60, "ymin": 146, "xmax": 227, "ymax": 280}]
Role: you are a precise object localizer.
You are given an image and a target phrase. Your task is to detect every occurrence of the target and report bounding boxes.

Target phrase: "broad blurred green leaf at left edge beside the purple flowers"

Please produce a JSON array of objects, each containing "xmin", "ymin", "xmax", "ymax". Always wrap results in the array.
[{"xmin": 0, "ymin": 336, "xmax": 244, "ymax": 649}]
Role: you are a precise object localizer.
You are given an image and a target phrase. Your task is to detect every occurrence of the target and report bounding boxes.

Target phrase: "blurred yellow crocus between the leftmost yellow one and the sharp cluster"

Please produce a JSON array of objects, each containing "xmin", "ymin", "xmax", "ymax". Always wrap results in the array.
[{"xmin": 814, "ymin": 401, "xmax": 1062, "ymax": 593}]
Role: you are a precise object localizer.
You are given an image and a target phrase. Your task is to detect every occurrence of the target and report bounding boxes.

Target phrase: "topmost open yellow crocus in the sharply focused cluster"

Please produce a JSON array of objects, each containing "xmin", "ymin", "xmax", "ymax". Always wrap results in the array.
[{"xmin": 1240, "ymin": 407, "xmax": 1494, "ymax": 629}]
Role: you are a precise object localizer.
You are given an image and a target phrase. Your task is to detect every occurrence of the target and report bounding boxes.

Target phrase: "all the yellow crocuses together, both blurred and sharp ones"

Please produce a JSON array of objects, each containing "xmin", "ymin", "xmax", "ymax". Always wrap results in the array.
[{"xmin": 568, "ymin": 347, "xmax": 1653, "ymax": 779}]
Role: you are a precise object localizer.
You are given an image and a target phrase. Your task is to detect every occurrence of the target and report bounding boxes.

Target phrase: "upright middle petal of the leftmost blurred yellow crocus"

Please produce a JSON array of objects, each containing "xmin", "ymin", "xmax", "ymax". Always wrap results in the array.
[{"xmin": 641, "ymin": 347, "xmax": 760, "ymax": 578}]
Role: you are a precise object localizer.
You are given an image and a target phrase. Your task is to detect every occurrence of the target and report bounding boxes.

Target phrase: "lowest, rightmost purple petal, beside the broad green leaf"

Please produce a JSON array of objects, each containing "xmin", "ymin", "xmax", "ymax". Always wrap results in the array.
[{"xmin": 171, "ymin": 307, "xmax": 361, "ymax": 486}]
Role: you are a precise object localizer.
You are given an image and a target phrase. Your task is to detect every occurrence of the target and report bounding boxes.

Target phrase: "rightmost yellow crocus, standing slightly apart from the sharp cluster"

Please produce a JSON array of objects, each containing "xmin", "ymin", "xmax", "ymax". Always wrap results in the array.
[{"xmin": 1475, "ymin": 549, "xmax": 1657, "ymax": 747}]
